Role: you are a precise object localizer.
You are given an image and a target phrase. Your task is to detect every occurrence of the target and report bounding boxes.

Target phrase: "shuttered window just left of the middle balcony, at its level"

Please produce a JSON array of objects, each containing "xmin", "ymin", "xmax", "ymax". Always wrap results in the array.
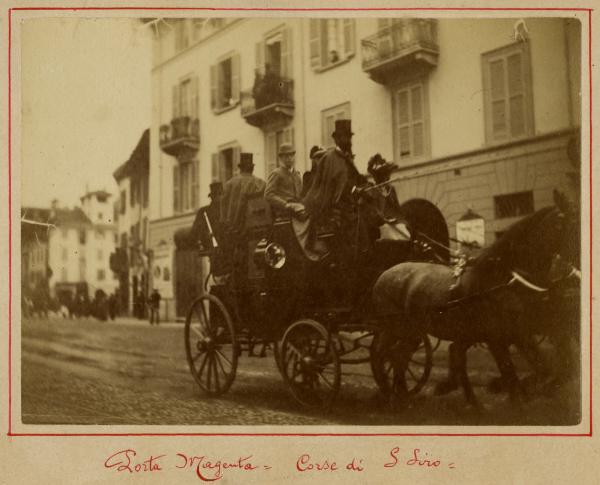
[{"xmin": 210, "ymin": 54, "xmax": 240, "ymax": 112}]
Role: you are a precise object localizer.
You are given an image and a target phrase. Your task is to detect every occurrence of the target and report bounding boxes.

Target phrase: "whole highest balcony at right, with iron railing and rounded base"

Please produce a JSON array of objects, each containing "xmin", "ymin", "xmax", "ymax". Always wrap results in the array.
[{"xmin": 361, "ymin": 19, "xmax": 439, "ymax": 84}]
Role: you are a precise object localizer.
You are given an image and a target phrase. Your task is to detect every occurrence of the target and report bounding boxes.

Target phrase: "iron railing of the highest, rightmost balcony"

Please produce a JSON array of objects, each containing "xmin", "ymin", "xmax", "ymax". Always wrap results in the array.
[{"xmin": 361, "ymin": 19, "xmax": 439, "ymax": 71}]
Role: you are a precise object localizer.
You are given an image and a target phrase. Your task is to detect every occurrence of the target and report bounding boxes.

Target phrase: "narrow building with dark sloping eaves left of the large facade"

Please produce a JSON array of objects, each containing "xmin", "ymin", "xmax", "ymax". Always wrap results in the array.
[{"xmin": 111, "ymin": 130, "xmax": 150, "ymax": 318}]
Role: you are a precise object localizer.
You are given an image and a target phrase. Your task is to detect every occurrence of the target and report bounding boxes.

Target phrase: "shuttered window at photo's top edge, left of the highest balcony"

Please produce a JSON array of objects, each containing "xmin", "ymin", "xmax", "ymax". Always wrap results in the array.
[{"xmin": 310, "ymin": 19, "xmax": 356, "ymax": 70}]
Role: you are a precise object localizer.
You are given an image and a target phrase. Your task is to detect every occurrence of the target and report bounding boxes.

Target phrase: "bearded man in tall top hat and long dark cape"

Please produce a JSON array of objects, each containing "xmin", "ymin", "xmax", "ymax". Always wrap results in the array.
[{"xmin": 302, "ymin": 120, "xmax": 367, "ymax": 257}]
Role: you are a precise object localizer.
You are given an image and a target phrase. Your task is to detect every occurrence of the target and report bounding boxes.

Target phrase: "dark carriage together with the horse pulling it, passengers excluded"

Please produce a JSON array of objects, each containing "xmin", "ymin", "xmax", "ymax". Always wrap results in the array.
[{"xmin": 185, "ymin": 188, "xmax": 573, "ymax": 407}]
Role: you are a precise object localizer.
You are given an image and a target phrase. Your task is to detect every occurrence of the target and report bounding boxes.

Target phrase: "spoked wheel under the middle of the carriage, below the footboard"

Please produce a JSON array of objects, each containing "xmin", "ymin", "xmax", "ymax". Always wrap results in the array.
[{"xmin": 281, "ymin": 319, "xmax": 341, "ymax": 408}]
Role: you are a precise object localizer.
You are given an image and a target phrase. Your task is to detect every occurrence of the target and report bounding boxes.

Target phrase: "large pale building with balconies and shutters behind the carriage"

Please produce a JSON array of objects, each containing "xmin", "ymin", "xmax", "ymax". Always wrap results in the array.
[{"xmin": 149, "ymin": 18, "xmax": 581, "ymax": 315}]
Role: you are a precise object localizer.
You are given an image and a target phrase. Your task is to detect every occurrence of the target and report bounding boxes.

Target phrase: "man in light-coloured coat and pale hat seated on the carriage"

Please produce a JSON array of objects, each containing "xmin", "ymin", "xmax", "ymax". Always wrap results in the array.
[{"xmin": 265, "ymin": 143, "xmax": 305, "ymax": 218}]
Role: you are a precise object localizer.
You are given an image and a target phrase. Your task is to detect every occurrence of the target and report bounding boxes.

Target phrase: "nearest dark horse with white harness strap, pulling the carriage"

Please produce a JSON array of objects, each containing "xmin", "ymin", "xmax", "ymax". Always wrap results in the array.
[{"xmin": 373, "ymin": 192, "xmax": 576, "ymax": 405}]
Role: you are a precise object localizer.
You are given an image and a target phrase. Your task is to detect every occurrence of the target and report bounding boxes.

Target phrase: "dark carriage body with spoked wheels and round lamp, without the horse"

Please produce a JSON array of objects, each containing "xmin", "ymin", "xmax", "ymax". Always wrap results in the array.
[{"xmin": 180, "ymin": 190, "xmax": 442, "ymax": 407}]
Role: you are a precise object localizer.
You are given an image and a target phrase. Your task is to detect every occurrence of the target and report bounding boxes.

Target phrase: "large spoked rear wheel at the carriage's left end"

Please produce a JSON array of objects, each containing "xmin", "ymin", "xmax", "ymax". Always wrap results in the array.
[{"xmin": 185, "ymin": 295, "xmax": 238, "ymax": 396}]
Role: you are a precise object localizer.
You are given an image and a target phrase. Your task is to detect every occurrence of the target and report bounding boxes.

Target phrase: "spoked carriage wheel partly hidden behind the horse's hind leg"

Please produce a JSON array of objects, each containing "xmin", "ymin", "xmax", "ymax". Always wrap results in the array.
[{"xmin": 371, "ymin": 332, "xmax": 433, "ymax": 396}]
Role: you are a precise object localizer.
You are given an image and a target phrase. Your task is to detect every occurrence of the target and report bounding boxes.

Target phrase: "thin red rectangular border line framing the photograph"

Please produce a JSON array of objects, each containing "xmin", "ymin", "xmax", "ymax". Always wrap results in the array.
[{"xmin": 7, "ymin": 7, "xmax": 593, "ymax": 437}]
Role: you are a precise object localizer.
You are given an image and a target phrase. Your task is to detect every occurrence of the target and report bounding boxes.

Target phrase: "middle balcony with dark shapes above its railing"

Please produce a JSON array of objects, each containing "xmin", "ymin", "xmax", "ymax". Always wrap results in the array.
[{"xmin": 241, "ymin": 75, "xmax": 294, "ymax": 129}]
